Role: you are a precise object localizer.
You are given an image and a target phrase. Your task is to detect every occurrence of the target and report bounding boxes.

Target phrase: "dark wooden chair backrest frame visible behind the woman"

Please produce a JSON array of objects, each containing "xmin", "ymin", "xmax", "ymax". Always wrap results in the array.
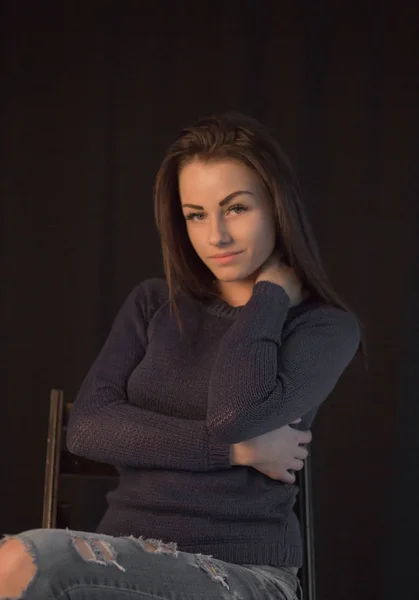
[{"xmin": 42, "ymin": 389, "xmax": 316, "ymax": 600}]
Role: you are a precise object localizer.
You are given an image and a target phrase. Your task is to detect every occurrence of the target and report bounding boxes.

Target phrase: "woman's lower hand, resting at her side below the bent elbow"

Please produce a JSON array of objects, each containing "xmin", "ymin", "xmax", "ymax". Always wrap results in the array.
[{"xmin": 230, "ymin": 419, "xmax": 312, "ymax": 483}]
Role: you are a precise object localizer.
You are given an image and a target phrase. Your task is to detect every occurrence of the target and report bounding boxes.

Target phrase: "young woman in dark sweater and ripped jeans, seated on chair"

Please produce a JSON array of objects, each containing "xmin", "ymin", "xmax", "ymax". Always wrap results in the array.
[{"xmin": 0, "ymin": 113, "xmax": 362, "ymax": 600}]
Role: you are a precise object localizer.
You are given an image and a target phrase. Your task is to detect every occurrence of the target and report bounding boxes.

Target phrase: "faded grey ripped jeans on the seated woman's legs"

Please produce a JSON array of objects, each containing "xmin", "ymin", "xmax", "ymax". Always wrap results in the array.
[{"xmin": 0, "ymin": 529, "xmax": 302, "ymax": 600}]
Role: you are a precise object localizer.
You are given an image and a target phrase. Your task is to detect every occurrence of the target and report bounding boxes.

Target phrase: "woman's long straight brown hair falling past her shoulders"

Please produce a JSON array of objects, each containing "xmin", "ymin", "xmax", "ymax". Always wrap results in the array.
[{"xmin": 154, "ymin": 112, "xmax": 366, "ymax": 361}]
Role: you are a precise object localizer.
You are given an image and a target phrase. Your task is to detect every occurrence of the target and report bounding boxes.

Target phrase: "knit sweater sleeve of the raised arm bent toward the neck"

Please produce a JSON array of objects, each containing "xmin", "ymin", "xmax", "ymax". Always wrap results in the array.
[{"xmin": 207, "ymin": 281, "xmax": 360, "ymax": 444}]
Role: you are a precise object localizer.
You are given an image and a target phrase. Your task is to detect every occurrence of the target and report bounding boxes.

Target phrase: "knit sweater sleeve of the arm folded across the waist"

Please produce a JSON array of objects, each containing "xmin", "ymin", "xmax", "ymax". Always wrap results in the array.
[{"xmin": 67, "ymin": 284, "xmax": 231, "ymax": 471}]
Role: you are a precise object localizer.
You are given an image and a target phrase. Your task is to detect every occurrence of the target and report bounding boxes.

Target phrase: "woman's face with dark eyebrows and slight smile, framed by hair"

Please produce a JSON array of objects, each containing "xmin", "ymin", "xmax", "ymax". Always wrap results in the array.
[{"xmin": 179, "ymin": 159, "xmax": 276, "ymax": 282}]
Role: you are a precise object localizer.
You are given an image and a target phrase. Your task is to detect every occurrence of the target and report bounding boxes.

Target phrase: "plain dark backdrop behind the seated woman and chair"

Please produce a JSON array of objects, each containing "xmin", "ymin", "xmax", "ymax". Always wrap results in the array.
[{"xmin": 0, "ymin": 0, "xmax": 419, "ymax": 600}]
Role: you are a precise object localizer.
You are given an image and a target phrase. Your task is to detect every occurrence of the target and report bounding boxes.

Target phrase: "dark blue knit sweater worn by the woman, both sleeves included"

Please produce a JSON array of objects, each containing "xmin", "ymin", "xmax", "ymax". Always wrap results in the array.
[{"xmin": 67, "ymin": 279, "xmax": 360, "ymax": 567}]
